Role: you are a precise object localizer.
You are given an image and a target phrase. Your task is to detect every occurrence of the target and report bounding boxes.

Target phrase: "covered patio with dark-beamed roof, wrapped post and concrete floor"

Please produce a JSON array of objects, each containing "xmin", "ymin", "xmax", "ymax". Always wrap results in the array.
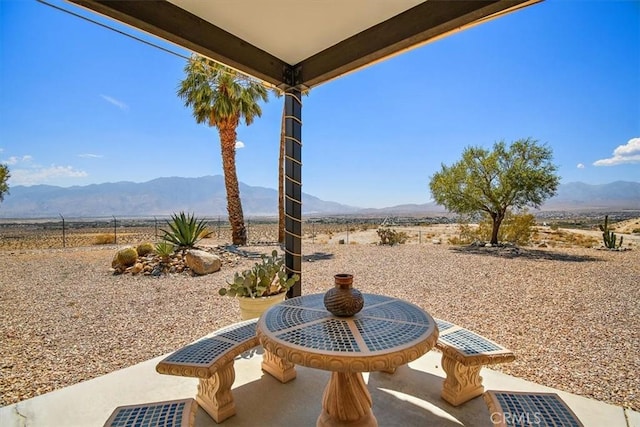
[{"xmin": 5, "ymin": 0, "xmax": 640, "ymax": 426}]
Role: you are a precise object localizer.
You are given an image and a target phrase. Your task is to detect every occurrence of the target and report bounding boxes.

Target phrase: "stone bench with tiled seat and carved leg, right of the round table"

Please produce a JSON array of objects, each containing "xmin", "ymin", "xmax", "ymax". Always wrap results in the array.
[{"xmin": 435, "ymin": 319, "xmax": 516, "ymax": 406}]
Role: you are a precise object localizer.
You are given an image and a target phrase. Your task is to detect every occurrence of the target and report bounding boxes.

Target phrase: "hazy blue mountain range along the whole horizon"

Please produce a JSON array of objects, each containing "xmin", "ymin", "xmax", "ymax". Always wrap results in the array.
[{"xmin": 0, "ymin": 175, "xmax": 640, "ymax": 218}]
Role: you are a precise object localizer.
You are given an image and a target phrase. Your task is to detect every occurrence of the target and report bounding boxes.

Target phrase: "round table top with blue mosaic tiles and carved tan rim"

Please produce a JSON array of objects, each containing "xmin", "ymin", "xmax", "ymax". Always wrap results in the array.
[{"xmin": 257, "ymin": 294, "xmax": 438, "ymax": 372}]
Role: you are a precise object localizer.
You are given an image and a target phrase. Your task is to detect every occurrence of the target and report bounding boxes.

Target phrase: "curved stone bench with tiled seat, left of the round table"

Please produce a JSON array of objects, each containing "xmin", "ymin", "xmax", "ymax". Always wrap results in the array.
[{"xmin": 156, "ymin": 319, "xmax": 296, "ymax": 423}]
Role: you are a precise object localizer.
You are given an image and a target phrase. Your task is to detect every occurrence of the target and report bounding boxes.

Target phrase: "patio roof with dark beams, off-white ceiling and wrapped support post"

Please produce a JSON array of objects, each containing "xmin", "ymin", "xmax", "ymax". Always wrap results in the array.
[{"xmin": 67, "ymin": 0, "xmax": 542, "ymax": 297}]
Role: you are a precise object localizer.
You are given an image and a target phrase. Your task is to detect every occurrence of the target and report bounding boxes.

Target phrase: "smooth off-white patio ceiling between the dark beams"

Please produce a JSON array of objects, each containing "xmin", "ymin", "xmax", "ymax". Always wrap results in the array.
[{"xmin": 169, "ymin": 0, "xmax": 425, "ymax": 65}]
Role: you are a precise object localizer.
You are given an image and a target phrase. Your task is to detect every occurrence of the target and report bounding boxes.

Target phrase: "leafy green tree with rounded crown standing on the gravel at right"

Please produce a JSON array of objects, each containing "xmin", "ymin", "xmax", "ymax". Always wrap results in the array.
[{"xmin": 429, "ymin": 138, "xmax": 560, "ymax": 244}]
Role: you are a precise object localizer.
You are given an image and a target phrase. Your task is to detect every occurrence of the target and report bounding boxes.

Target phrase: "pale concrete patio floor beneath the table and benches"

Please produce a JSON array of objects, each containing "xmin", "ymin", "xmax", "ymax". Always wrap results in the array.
[{"xmin": 0, "ymin": 347, "xmax": 640, "ymax": 427}]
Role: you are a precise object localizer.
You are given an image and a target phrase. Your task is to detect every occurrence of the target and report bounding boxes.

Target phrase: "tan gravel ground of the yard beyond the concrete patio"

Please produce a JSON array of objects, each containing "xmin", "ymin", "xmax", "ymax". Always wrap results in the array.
[{"xmin": 0, "ymin": 239, "xmax": 640, "ymax": 411}]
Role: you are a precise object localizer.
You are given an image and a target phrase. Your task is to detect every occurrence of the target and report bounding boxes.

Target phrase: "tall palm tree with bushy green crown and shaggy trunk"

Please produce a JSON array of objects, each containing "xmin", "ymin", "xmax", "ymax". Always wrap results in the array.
[{"xmin": 178, "ymin": 55, "xmax": 268, "ymax": 245}]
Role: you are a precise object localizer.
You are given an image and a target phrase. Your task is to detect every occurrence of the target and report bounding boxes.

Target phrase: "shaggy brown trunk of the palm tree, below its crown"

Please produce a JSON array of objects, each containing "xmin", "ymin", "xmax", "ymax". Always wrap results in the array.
[{"xmin": 218, "ymin": 117, "xmax": 247, "ymax": 245}]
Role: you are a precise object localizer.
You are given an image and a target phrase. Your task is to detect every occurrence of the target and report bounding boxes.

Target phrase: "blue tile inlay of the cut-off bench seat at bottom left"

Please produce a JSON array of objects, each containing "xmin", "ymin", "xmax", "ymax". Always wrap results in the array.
[{"xmin": 109, "ymin": 402, "xmax": 186, "ymax": 427}]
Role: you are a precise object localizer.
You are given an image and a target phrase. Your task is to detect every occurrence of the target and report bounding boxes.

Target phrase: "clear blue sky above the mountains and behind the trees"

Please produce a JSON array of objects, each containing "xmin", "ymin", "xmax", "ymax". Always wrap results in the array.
[{"xmin": 0, "ymin": 0, "xmax": 640, "ymax": 207}]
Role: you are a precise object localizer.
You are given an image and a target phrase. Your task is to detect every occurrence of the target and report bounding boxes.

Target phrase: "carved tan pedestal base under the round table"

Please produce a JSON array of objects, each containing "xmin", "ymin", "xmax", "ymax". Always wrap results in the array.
[{"xmin": 316, "ymin": 372, "xmax": 378, "ymax": 427}]
